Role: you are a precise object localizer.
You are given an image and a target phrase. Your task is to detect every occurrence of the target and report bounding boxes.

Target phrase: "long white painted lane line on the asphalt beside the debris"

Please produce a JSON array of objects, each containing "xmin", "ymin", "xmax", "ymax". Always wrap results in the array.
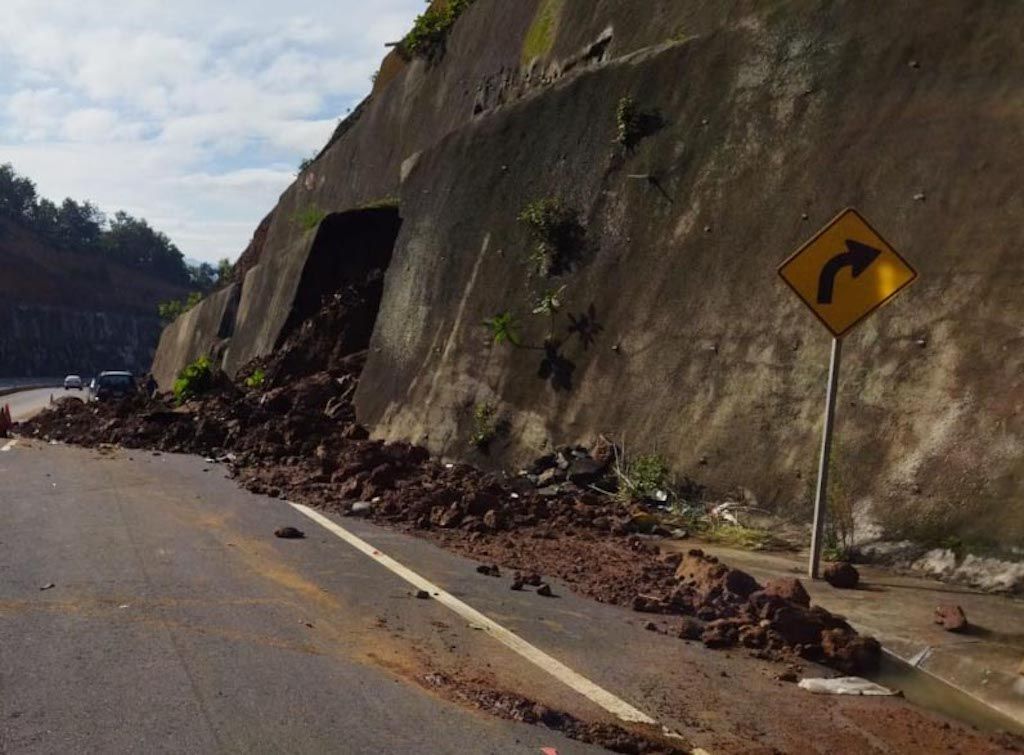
[{"xmin": 288, "ymin": 501, "xmax": 657, "ymax": 725}]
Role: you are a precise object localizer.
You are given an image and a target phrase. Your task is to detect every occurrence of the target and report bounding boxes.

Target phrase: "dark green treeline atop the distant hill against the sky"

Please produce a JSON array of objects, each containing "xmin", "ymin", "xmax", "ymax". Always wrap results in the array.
[{"xmin": 0, "ymin": 163, "xmax": 230, "ymax": 292}]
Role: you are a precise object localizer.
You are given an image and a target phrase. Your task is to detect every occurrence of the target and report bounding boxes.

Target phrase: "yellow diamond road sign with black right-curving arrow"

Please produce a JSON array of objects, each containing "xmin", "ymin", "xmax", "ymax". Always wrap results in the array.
[{"xmin": 778, "ymin": 209, "xmax": 918, "ymax": 338}]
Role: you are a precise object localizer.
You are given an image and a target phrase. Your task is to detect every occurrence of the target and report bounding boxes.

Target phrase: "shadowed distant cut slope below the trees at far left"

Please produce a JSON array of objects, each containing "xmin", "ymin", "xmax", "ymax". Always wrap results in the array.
[{"xmin": 0, "ymin": 220, "xmax": 183, "ymax": 377}]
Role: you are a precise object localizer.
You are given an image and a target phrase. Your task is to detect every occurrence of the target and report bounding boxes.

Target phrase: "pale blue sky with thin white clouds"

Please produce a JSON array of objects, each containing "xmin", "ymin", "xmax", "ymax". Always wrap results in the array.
[{"xmin": 0, "ymin": 0, "xmax": 425, "ymax": 262}]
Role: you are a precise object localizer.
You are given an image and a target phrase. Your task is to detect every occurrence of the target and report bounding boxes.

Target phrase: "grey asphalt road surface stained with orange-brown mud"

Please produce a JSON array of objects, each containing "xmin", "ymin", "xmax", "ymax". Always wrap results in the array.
[{"xmin": 0, "ymin": 439, "xmax": 1011, "ymax": 755}]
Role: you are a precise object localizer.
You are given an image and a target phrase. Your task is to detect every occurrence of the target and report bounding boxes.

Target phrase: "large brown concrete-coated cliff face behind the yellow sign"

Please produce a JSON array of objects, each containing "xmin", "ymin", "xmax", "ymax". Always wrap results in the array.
[{"xmin": 153, "ymin": 0, "xmax": 1024, "ymax": 548}]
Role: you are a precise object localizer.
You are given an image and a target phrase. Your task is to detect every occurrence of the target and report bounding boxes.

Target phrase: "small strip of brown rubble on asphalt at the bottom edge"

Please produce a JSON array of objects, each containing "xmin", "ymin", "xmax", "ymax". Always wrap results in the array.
[{"xmin": 422, "ymin": 673, "xmax": 690, "ymax": 755}]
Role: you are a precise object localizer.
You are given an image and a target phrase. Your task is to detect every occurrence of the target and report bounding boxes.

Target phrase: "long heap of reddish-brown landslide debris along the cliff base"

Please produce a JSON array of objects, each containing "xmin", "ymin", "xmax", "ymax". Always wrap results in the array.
[{"xmin": 18, "ymin": 287, "xmax": 880, "ymax": 673}]
